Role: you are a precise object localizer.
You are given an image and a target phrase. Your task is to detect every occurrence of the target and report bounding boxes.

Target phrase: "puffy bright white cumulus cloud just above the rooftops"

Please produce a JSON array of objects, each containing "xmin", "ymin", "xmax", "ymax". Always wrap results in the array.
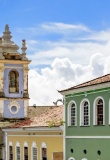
[{"xmin": 29, "ymin": 53, "xmax": 104, "ymax": 105}]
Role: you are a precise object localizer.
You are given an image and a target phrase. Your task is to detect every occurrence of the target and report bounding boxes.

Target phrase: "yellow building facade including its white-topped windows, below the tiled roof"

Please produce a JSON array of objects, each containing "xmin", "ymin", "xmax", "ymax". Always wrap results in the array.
[{"xmin": 5, "ymin": 127, "xmax": 63, "ymax": 160}]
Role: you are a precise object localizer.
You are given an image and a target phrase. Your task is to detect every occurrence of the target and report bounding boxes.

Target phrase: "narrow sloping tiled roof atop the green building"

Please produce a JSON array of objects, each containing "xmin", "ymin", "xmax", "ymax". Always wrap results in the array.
[{"xmin": 59, "ymin": 74, "xmax": 110, "ymax": 92}]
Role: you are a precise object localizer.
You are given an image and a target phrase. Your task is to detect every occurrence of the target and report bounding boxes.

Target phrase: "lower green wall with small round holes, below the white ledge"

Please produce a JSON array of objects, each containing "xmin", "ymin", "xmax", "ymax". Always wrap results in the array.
[{"xmin": 65, "ymin": 138, "xmax": 110, "ymax": 160}]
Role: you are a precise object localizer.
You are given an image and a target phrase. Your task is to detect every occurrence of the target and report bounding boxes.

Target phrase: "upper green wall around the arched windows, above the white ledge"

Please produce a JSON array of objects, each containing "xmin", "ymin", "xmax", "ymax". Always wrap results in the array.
[{"xmin": 65, "ymin": 88, "xmax": 110, "ymax": 136}]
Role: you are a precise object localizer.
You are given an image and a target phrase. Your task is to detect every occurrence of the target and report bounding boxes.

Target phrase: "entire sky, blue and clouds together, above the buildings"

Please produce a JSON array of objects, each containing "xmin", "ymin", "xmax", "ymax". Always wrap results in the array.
[{"xmin": 0, "ymin": 0, "xmax": 110, "ymax": 105}]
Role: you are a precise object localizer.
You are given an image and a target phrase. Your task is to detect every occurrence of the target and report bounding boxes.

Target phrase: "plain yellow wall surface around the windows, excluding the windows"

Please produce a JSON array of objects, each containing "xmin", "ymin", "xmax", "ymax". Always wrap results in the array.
[{"xmin": 7, "ymin": 132, "xmax": 63, "ymax": 160}]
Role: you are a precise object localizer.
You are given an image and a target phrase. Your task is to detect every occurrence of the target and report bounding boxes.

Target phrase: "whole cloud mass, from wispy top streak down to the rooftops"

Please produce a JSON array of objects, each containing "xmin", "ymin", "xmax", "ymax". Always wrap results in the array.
[{"xmin": 13, "ymin": 23, "xmax": 110, "ymax": 105}]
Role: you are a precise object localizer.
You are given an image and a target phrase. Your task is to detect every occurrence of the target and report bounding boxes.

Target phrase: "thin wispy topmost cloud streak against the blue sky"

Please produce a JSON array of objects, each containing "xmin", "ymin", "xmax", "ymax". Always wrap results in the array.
[{"xmin": 16, "ymin": 22, "xmax": 91, "ymax": 38}]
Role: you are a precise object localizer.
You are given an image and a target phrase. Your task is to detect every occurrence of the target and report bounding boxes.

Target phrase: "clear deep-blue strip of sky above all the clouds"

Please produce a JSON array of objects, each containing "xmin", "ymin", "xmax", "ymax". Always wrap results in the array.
[{"xmin": 0, "ymin": 0, "xmax": 110, "ymax": 29}]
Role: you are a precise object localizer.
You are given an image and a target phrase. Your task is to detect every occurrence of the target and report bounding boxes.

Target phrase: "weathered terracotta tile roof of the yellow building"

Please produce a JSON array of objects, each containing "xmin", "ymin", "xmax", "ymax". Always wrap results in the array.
[{"xmin": 8, "ymin": 106, "xmax": 63, "ymax": 128}]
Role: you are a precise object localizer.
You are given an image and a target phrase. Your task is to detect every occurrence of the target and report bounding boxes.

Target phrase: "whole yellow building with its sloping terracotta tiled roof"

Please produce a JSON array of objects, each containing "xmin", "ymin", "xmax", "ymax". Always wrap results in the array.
[{"xmin": 3, "ymin": 106, "xmax": 63, "ymax": 160}]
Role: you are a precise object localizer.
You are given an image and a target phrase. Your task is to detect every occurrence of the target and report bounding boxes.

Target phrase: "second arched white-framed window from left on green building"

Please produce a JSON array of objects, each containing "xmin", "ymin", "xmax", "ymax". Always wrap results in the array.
[{"xmin": 80, "ymin": 99, "xmax": 90, "ymax": 126}]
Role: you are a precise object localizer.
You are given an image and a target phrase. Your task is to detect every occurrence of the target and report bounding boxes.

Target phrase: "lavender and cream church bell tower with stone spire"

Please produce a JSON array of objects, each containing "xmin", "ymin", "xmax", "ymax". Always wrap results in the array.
[{"xmin": 0, "ymin": 24, "xmax": 30, "ymax": 119}]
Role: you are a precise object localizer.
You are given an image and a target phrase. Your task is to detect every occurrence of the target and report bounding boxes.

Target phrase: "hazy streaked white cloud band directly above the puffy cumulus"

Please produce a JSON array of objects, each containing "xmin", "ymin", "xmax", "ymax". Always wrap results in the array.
[{"xmin": 28, "ymin": 39, "xmax": 110, "ymax": 66}]
